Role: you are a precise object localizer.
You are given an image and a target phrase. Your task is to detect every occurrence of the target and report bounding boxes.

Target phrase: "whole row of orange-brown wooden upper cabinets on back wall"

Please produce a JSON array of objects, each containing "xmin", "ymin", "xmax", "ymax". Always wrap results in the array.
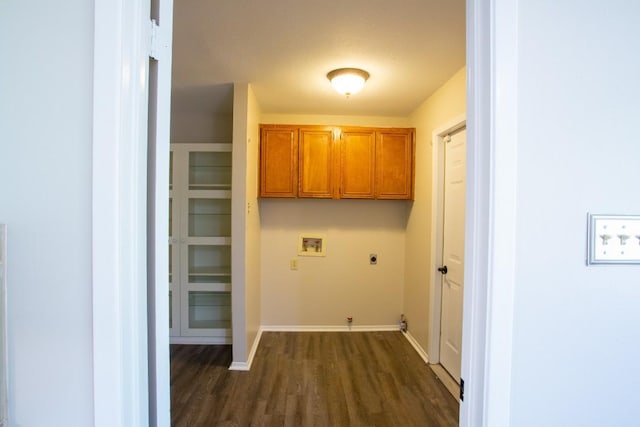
[{"xmin": 260, "ymin": 125, "xmax": 415, "ymax": 200}]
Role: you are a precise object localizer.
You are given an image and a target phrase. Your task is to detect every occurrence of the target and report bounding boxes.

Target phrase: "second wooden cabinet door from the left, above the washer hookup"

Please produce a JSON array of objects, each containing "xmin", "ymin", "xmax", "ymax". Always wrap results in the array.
[{"xmin": 298, "ymin": 128, "xmax": 335, "ymax": 198}]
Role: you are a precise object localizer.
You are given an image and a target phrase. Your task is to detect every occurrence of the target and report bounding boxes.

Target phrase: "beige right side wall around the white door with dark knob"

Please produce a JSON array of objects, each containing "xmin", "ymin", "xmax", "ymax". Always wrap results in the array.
[{"xmin": 404, "ymin": 68, "xmax": 466, "ymax": 358}]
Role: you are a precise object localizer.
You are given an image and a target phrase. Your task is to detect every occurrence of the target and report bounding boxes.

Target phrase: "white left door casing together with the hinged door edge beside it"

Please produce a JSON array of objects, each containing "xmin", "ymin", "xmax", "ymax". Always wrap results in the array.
[{"xmin": 92, "ymin": 0, "xmax": 173, "ymax": 427}]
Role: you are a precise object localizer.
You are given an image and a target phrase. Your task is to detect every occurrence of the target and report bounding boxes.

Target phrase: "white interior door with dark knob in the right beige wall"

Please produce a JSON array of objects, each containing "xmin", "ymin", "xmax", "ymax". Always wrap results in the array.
[{"xmin": 440, "ymin": 128, "xmax": 466, "ymax": 383}]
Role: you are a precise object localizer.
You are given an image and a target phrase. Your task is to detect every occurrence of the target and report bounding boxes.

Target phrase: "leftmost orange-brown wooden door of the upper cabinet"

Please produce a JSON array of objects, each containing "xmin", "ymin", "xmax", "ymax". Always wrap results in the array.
[{"xmin": 260, "ymin": 127, "xmax": 298, "ymax": 197}]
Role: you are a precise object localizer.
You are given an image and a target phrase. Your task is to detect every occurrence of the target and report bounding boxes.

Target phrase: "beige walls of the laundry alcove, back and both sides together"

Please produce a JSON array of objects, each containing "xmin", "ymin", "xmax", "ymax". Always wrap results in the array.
[{"xmin": 170, "ymin": 69, "xmax": 465, "ymax": 352}]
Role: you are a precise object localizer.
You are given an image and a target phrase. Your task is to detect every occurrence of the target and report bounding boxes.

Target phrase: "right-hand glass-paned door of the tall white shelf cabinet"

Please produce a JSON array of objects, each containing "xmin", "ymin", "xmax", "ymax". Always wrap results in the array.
[{"xmin": 180, "ymin": 149, "xmax": 232, "ymax": 338}]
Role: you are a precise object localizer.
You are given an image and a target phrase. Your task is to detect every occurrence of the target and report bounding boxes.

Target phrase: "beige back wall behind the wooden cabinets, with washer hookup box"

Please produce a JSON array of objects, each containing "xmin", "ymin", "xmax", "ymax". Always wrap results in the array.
[{"xmin": 260, "ymin": 115, "xmax": 408, "ymax": 328}]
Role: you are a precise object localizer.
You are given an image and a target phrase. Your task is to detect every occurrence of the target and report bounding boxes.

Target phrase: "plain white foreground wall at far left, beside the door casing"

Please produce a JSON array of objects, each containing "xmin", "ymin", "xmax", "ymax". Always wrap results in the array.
[{"xmin": 0, "ymin": 0, "xmax": 93, "ymax": 427}]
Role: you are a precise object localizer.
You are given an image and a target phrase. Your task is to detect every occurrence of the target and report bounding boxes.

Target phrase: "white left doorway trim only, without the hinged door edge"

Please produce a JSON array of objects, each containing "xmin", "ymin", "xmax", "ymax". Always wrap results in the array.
[{"xmin": 91, "ymin": 0, "xmax": 150, "ymax": 427}]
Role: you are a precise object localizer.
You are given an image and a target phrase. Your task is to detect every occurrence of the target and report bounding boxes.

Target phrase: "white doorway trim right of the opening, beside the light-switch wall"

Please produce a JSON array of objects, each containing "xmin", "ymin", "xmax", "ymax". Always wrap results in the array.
[{"xmin": 460, "ymin": 0, "xmax": 518, "ymax": 427}]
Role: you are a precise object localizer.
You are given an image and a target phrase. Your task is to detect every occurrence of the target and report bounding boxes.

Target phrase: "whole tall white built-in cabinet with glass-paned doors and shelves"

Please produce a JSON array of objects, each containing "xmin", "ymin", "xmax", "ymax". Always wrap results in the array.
[{"xmin": 169, "ymin": 144, "xmax": 232, "ymax": 344}]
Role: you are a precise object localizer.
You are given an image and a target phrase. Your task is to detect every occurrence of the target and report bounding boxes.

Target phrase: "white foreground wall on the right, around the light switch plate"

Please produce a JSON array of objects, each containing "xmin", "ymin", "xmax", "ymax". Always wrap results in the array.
[{"xmin": 504, "ymin": 0, "xmax": 640, "ymax": 426}]
